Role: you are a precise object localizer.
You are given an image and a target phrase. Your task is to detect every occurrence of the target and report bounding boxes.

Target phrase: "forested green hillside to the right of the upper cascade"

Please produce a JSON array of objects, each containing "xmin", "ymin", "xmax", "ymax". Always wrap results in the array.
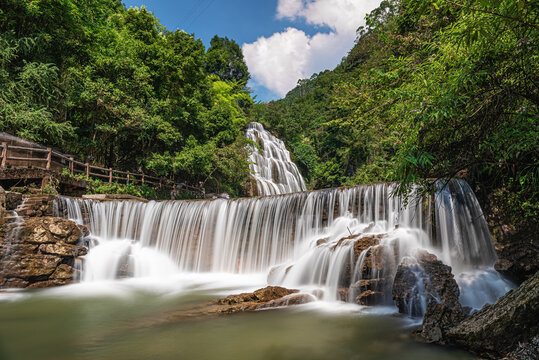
[{"xmin": 257, "ymin": 0, "xmax": 539, "ymax": 231}]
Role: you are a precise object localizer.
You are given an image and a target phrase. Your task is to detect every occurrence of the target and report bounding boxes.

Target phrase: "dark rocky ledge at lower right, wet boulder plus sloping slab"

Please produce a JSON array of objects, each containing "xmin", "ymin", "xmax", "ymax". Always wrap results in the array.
[{"xmin": 393, "ymin": 251, "xmax": 539, "ymax": 359}]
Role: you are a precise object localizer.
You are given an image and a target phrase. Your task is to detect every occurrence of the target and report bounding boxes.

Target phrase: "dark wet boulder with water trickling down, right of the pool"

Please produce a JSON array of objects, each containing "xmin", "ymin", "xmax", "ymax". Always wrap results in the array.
[{"xmin": 393, "ymin": 250, "xmax": 466, "ymax": 344}]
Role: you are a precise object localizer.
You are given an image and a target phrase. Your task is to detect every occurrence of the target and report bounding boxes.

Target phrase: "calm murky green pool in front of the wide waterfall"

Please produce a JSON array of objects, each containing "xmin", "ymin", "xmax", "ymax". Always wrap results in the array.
[{"xmin": 0, "ymin": 292, "xmax": 473, "ymax": 360}]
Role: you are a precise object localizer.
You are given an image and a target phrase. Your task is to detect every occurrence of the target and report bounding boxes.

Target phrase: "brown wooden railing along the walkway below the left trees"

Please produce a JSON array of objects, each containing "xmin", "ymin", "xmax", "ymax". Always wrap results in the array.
[{"xmin": 1, "ymin": 142, "xmax": 172, "ymax": 189}]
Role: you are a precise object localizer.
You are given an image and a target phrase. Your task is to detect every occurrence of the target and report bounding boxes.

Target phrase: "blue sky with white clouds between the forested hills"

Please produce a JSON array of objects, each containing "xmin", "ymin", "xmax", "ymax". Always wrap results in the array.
[{"xmin": 123, "ymin": 0, "xmax": 381, "ymax": 101}]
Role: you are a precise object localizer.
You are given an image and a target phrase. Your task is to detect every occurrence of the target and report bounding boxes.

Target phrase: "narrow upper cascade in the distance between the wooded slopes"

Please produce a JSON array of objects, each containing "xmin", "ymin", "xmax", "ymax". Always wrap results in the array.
[{"xmin": 245, "ymin": 122, "xmax": 307, "ymax": 195}]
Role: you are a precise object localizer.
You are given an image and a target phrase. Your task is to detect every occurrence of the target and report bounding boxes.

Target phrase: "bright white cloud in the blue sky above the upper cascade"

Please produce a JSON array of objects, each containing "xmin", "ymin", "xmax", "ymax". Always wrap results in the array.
[{"xmin": 243, "ymin": 0, "xmax": 380, "ymax": 96}]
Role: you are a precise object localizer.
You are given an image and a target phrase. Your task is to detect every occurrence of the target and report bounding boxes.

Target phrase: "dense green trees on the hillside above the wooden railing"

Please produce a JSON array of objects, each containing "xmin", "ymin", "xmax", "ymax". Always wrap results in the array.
[{"xmin": 0, "ymin": 0, "xmax": 252, "ymax": 195}]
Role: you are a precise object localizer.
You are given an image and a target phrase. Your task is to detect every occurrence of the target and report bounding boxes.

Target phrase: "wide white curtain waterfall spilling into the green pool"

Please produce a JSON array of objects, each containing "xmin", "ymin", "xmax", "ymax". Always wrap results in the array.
[{"xmin": 57, "ymin": 180, "xmax": 510, "ymax": 308}]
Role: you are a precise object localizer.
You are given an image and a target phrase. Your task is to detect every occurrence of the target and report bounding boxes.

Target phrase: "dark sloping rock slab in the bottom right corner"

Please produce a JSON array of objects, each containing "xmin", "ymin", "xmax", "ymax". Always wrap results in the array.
[{"xmin": 447, "ymin": 272, "xmax": 539, "ymax": 358}]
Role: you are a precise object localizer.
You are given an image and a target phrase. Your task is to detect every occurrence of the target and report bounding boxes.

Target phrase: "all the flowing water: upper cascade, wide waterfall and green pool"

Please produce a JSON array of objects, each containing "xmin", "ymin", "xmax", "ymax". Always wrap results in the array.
[{"xmin": 0, "ymin": 123, "xmax": 512, "ymax": 359}]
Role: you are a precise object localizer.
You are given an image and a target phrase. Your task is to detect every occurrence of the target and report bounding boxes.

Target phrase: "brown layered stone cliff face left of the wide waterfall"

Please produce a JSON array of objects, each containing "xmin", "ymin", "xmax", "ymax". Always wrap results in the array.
[{"xmin": 0, "ymin": 196, "xmax": 88, "ymax": 289}]
